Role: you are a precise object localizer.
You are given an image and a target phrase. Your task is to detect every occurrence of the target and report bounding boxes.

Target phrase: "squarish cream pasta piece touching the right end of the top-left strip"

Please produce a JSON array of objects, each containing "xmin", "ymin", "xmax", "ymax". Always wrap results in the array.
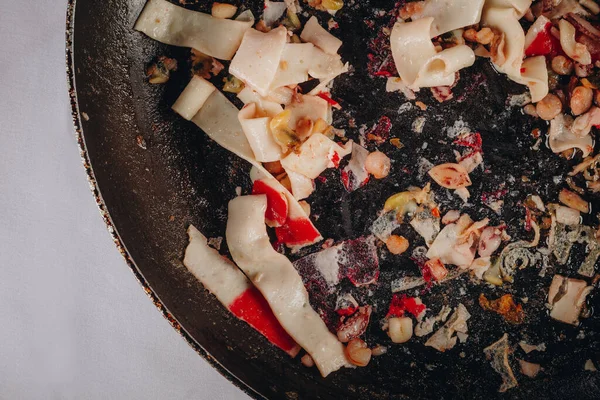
[{"xmin": 229, "ymin": 26, "xmax": 287, "ymax": 97}]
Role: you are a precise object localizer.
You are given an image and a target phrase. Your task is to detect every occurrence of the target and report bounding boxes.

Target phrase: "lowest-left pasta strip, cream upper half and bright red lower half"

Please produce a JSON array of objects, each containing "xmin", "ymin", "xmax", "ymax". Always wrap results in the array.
[{"xmin": 183, "ymin": 225, "xmax": 300, "ymax": 357}]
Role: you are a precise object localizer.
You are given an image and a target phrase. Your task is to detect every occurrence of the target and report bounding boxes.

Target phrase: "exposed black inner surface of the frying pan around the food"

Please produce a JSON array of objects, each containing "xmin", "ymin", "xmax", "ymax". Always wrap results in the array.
[{"xmin": 67, "ymin": 0, "xmax": 600, "ymax": 399}]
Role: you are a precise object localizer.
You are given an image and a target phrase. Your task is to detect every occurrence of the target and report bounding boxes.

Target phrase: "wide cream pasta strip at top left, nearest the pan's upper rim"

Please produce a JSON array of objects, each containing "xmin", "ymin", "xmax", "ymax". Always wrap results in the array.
[{"xmin": 134, "ymin": 0, "xmax": 254, "ymax": 60}]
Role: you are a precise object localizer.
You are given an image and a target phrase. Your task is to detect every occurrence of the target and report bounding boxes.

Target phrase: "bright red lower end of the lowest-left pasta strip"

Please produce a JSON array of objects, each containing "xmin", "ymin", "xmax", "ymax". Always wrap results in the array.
[{"xmin": 229, "ymin": 287, "xmax": 297, "ymax": 353}]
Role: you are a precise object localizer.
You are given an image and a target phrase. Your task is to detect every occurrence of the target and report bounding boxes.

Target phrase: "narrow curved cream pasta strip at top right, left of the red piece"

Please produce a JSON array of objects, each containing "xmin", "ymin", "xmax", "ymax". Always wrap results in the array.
[{"xmin": 482, "ymin": 8, "xmax": 525, "ymax": 78}]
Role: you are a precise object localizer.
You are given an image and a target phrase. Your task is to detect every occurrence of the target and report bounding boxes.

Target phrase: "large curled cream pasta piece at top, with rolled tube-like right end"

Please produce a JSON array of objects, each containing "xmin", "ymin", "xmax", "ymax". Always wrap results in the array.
[{"xmin": 390, "ymin": 17, "xmax": 475, "ymax": 90}]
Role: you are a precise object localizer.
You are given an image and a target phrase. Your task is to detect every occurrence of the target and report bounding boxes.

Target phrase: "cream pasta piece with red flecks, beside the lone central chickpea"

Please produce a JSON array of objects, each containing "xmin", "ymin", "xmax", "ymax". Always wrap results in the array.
[{"xmin": 281, "ymin": 133, "xmax": 352, "ymax": 179}]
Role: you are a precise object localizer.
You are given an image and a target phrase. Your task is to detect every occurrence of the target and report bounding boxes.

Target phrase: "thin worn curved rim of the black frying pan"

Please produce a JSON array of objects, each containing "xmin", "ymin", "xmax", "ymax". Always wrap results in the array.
[{"xmin": 65, "ymin": 0, "xmax": 265, "ymax": 399}]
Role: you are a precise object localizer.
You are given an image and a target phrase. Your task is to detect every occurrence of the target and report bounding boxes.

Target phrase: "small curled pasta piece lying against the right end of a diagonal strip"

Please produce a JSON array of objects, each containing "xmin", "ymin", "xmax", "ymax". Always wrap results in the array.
[{"xmin": 238, "ymin": 103, "xmax": 283, "ymax": 162}]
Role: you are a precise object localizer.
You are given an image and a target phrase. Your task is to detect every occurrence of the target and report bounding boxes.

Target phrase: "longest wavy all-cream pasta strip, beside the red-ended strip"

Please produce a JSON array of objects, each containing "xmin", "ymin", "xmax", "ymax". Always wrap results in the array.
[{"xmin": 226, "ymin": 196, "xmax": 350, "ymax": 377}]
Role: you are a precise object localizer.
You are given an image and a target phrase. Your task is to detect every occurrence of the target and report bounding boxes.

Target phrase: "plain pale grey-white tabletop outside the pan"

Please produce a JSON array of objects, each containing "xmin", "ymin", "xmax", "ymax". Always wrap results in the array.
[{"xmin": 0, "ymin": 0, "xmax": 247, "ymax": 400}]
